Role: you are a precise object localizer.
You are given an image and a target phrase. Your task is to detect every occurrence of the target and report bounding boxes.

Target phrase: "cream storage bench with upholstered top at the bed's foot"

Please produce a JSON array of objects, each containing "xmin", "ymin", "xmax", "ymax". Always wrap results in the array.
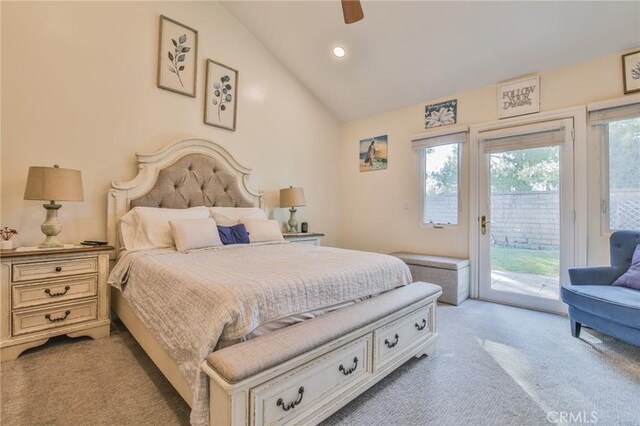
[{"xmin": 202, "ymin": 282, "xmax": 442, "ymax": 425}]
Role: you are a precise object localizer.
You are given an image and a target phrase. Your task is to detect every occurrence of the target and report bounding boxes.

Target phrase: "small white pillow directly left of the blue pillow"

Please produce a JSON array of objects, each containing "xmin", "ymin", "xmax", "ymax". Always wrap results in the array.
[{"xmin": 169, "ymin": 218, "xmax": 222, "ymax": 253}]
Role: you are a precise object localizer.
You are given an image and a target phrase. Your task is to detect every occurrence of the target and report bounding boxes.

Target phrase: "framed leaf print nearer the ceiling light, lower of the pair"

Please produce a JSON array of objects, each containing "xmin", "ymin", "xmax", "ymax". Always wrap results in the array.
[{"xmin": 204, "ymin": 59, "xmax": 238, "ymax": 131}]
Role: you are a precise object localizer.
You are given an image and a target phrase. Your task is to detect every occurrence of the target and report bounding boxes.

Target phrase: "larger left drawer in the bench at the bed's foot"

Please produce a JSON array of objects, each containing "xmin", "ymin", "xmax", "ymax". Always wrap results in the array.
[{"xmin": 250, "ymin": 334, "xmax": 372, "ymax": 425}]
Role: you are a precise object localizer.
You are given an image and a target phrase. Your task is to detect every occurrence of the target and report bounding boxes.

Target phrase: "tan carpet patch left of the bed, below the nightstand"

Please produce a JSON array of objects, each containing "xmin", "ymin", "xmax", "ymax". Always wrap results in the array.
[{"xmin": 0, "ymin": 322, "xmax": 190, "ymax": 426}]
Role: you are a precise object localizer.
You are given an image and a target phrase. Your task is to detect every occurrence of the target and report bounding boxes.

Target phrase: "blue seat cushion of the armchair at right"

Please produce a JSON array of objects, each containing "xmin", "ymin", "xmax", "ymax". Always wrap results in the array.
[{"xmin": 561, "ymin": 285, "xmax": 640, "ymax": 329}]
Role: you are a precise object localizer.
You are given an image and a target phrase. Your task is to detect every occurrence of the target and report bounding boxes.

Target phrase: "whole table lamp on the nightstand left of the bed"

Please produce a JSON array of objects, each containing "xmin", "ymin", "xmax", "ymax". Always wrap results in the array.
[{"xmin": 24, "ymin": 164, "xmax": 84, "ymax": 248}]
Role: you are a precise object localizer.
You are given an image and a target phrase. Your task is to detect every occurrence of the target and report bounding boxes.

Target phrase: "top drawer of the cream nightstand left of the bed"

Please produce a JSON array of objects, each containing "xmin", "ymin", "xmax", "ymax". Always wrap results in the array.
[{"xmin": 12, "ymin": 257, "xmax": 98, "ymax": 282}]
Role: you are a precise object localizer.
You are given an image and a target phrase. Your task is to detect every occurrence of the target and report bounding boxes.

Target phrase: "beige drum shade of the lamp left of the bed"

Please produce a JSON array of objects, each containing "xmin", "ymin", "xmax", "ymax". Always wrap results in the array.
[{"xmin": 24, "ymin": 166, "xmax": 84, "ymax": 201}]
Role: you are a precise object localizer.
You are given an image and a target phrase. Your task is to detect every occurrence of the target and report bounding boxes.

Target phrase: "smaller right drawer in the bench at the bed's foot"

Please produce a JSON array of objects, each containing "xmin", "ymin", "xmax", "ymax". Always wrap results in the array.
[{"xmin": 373, "ymin": 303, "xmax": 434, "ymax": 368}]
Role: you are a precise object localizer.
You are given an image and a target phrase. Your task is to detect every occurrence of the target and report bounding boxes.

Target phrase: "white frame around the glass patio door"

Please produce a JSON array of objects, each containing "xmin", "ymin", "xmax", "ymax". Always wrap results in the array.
[{"xmin": 469, "ymin": 105, "xmax": 588, "ymax": 312}]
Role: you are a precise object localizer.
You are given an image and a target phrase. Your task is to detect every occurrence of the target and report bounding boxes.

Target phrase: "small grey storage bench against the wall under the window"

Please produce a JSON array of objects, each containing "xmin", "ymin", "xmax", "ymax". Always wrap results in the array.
[{"xmin": 390, "ymin": 252, "xmax": 469, "ymax": 306}]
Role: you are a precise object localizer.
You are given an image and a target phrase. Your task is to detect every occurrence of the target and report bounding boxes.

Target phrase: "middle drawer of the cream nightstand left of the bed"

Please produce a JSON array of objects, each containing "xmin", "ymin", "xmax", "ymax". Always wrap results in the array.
[{"xmin": 11, "ymin": 275, "xmax": 98, "ymax": 309}]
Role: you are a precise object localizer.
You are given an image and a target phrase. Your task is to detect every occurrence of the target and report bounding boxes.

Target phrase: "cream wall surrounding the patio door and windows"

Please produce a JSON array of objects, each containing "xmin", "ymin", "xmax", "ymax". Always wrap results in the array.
[{"xmin": 340, "ymin": 49, "xmax": 636, "ymax": 264}]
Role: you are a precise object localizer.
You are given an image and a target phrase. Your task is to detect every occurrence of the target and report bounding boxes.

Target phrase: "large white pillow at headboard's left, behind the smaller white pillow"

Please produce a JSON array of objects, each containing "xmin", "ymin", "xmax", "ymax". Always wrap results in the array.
[{"xmin": 120, "ymin": 206, "xmax": 209, "ymax": 250}]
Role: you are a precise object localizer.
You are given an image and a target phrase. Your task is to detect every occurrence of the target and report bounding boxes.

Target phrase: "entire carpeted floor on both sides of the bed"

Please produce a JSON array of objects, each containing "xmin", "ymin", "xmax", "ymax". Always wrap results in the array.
[{"xmin": 0, "ymin": 300, "xmax": 640, "ymax": 426}]
